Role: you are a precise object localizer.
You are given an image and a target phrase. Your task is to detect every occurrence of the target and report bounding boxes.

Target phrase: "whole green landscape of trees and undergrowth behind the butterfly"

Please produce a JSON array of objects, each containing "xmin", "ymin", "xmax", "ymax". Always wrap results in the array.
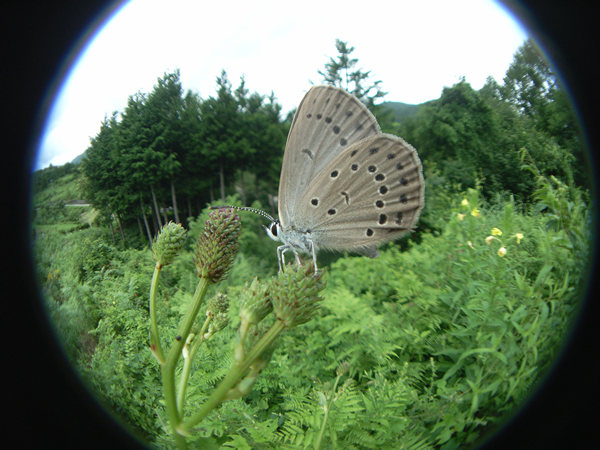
[{"xmin": 32, "ymin": 40, "xmax": 594, "ymax": 449}]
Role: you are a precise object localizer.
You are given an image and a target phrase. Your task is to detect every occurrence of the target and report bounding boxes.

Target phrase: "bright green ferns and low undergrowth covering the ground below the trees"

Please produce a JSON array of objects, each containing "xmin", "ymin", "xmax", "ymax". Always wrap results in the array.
[{"xmin": 36, "ymin": 164, "xmax": 590, "ymax": 448}]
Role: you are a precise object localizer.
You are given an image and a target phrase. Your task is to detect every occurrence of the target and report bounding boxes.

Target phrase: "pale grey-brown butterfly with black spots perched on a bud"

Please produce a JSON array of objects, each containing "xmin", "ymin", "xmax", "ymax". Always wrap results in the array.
[{"xmin": 216, "ymin": 86, "xmax": 425, "ymax": 272}]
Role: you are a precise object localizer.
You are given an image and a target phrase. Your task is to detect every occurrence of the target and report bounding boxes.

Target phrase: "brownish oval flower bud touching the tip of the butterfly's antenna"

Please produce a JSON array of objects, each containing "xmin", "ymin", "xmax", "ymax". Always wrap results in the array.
[{"xmin": 194, "ymin": 209, "xmax": 242, "ymax": 283}]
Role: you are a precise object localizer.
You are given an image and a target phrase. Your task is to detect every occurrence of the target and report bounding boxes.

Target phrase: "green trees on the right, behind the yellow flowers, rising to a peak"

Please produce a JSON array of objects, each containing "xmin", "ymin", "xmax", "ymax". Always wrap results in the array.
[{"xmin": 398, "ymin": 41, "xmax": 590, "ymax": 201}]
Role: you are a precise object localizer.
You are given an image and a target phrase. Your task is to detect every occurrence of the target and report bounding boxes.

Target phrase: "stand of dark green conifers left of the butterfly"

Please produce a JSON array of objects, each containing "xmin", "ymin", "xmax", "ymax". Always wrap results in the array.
[{"xmin": 82, "ymin": 71, "xmax": 286, "ymax": 240}]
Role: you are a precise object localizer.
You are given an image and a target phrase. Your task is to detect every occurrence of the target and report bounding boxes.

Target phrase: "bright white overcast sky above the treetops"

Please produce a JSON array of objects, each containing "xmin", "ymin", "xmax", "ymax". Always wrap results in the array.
[{"xmin": 36, "ymin": 0, "xmax": 527, "ymax": 169}]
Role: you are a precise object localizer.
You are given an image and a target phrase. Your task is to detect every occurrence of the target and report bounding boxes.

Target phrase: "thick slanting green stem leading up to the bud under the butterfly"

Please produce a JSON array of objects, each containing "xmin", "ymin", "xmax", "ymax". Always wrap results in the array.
[{"xmin": 178, "ymin": 320, "xmax": 285, "ymax": 435}]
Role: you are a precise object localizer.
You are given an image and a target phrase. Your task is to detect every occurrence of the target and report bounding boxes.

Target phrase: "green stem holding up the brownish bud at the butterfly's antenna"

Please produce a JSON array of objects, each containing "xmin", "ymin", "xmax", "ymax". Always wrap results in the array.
[{"xmin": 162, "ymin": 278, "xmax": 210, "ymax": 447}]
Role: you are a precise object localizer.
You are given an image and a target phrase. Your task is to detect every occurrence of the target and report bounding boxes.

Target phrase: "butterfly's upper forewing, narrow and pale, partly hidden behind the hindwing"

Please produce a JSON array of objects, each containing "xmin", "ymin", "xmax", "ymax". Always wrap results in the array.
[{"xmin": 279, "ymin": 86, "xmax": 380, "ymax": 227}]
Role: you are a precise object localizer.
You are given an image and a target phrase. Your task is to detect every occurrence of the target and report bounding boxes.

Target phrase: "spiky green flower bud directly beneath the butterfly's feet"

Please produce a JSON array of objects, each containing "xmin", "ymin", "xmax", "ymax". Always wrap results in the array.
[{"xmin": 270, "ymin": 264, "xmax": 325, "ymax": 328}]
